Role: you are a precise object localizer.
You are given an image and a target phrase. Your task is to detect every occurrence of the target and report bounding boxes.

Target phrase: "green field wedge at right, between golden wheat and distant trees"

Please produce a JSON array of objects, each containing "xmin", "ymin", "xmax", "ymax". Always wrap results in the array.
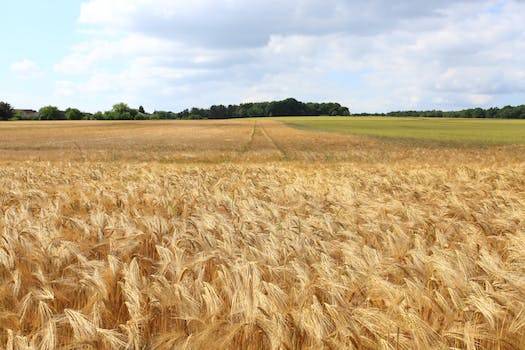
[{"xmin": 275, "ymin": 117, "xmax": 525, "ymax": 144}]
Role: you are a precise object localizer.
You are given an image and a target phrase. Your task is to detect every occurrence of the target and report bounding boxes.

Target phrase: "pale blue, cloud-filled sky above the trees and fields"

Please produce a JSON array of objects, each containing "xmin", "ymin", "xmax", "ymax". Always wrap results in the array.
[{"xmin": 0, "ymin": 0, "xmax": 525, "ymax": 112}]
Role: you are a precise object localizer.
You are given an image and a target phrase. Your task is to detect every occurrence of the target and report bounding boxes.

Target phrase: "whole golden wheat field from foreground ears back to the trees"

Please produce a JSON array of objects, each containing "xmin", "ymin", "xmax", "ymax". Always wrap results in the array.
[{"xmin": 0, "ymin": 121, "xmax": 525, "ymax": 349}]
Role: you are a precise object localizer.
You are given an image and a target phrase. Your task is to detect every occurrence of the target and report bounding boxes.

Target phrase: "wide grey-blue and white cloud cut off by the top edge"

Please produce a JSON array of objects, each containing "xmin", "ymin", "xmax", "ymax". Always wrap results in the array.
[{"xmin": 80, "ymin": 0, "xmax": 462, "ymax": 47}]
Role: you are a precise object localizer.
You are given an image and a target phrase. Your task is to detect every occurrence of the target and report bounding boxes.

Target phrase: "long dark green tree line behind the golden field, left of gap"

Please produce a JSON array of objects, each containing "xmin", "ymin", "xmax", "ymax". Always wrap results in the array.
[{"xmin": 0, "ymin": 98, "xmax": 350, "ymax": 120}]
